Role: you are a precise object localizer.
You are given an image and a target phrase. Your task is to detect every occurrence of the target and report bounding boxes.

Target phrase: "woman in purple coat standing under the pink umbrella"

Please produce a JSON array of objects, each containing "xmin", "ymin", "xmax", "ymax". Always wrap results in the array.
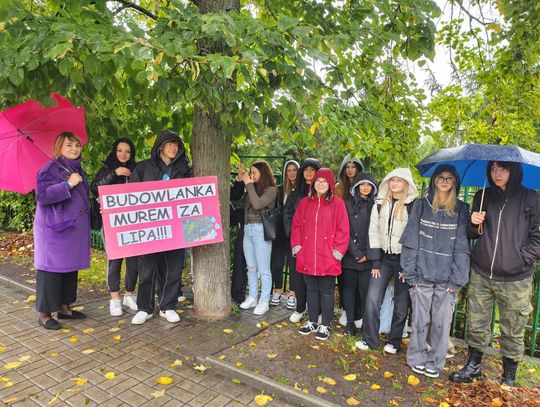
[{"xmin": 34, "ymin": 132, "xmax": 90, "ymax": 329}]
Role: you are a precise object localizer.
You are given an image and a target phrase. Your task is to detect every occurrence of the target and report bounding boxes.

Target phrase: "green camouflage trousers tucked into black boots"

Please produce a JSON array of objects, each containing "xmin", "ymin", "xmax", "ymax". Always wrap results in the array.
[{"xmin": 466, "ymin": 270, "xmax": 533, "ymax": 361}]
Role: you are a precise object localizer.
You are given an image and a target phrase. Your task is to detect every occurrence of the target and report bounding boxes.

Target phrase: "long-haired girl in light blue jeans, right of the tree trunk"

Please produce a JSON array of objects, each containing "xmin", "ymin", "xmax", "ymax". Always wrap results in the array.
[{"xmin": 238, "ymin": 161, "xmax": 277, "ymax": 315}]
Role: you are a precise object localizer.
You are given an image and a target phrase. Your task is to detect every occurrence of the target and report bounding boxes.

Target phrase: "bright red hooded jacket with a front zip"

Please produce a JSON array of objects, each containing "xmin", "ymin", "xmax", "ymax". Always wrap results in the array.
[{"xmin": 291, "ymin": 168, "xmax": 349, "ymax": 276}]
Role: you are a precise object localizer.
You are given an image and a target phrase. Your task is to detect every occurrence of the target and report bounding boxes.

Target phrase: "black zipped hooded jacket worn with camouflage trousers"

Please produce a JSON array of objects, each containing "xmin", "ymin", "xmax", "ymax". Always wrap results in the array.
[{"xmin": 468, "ymin": 162, "xmax": 540, "ymax": 281}]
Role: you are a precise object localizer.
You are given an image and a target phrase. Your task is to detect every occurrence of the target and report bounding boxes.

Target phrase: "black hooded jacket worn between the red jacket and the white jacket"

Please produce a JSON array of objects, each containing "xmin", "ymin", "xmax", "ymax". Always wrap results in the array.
[{"xmin": 341, "ymin": 172, "xmax": 377, "ymax": 271}]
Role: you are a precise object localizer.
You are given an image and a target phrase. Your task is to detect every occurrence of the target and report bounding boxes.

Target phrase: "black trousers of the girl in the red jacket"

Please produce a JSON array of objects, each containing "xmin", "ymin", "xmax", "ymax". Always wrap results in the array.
[{"xmin": 303, "ymin": 274, "xmax": 336, "ymax": 326}]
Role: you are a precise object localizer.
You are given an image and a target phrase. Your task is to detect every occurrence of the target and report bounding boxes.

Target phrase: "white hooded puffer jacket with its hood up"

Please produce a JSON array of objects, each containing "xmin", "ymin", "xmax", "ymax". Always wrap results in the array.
[{"xmin": 369, "ymin": 168, "xmax": 418, "ymax": 254}]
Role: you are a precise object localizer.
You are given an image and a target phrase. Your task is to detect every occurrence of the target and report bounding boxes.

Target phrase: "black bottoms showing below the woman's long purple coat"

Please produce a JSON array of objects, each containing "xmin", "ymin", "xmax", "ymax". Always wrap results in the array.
[{"xmin": 36, "ymin": 270, "xmax": 78, "ymax": 313}]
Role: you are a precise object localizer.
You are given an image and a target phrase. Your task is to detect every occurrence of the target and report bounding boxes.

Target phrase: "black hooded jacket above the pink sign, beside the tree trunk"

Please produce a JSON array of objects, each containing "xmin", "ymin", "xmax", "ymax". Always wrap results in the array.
[{"xmin": 129, "ymin": 130, "xmax": 191, "ymax": 182}]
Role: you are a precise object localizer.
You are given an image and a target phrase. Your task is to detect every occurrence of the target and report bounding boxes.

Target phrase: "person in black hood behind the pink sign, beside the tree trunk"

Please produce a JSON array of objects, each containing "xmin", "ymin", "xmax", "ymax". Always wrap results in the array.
[{"xmin": 130, "ymin": 130, "xmax": 191, "ymax": 325}]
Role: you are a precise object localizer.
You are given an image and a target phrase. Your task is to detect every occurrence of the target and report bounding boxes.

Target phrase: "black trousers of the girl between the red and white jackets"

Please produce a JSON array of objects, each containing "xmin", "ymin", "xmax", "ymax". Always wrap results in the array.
[{"xmin": 341, "ymin": 268, "xmax": 371, "ymax": 322}]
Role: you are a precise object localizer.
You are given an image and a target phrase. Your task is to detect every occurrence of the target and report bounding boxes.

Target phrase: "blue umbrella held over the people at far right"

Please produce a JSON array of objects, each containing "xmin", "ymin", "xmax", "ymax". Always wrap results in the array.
[{"xmin": 416, "ymin": 144, "xmax": 540, "ymax": 189}]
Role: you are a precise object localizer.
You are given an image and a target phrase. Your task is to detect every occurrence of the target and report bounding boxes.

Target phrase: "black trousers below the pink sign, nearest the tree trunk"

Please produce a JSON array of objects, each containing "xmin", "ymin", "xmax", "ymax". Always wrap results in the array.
[{"xmin": 137, "ymin": 249, "xmax": 185, "ymax": 314}]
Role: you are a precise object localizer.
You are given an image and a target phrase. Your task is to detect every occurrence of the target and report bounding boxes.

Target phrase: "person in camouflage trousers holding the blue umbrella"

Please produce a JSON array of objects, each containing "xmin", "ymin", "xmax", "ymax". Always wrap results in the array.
[{"xmin": 450, "ymin": 161, "xmax": 540, "ymax": 386}]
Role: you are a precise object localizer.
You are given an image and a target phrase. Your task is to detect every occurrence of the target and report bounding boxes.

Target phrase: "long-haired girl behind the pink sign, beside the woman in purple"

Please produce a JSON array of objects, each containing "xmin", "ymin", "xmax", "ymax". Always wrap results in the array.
[{"xmin": 90, "ymin": 137, "xmax": 139, "ymax": 317}]
